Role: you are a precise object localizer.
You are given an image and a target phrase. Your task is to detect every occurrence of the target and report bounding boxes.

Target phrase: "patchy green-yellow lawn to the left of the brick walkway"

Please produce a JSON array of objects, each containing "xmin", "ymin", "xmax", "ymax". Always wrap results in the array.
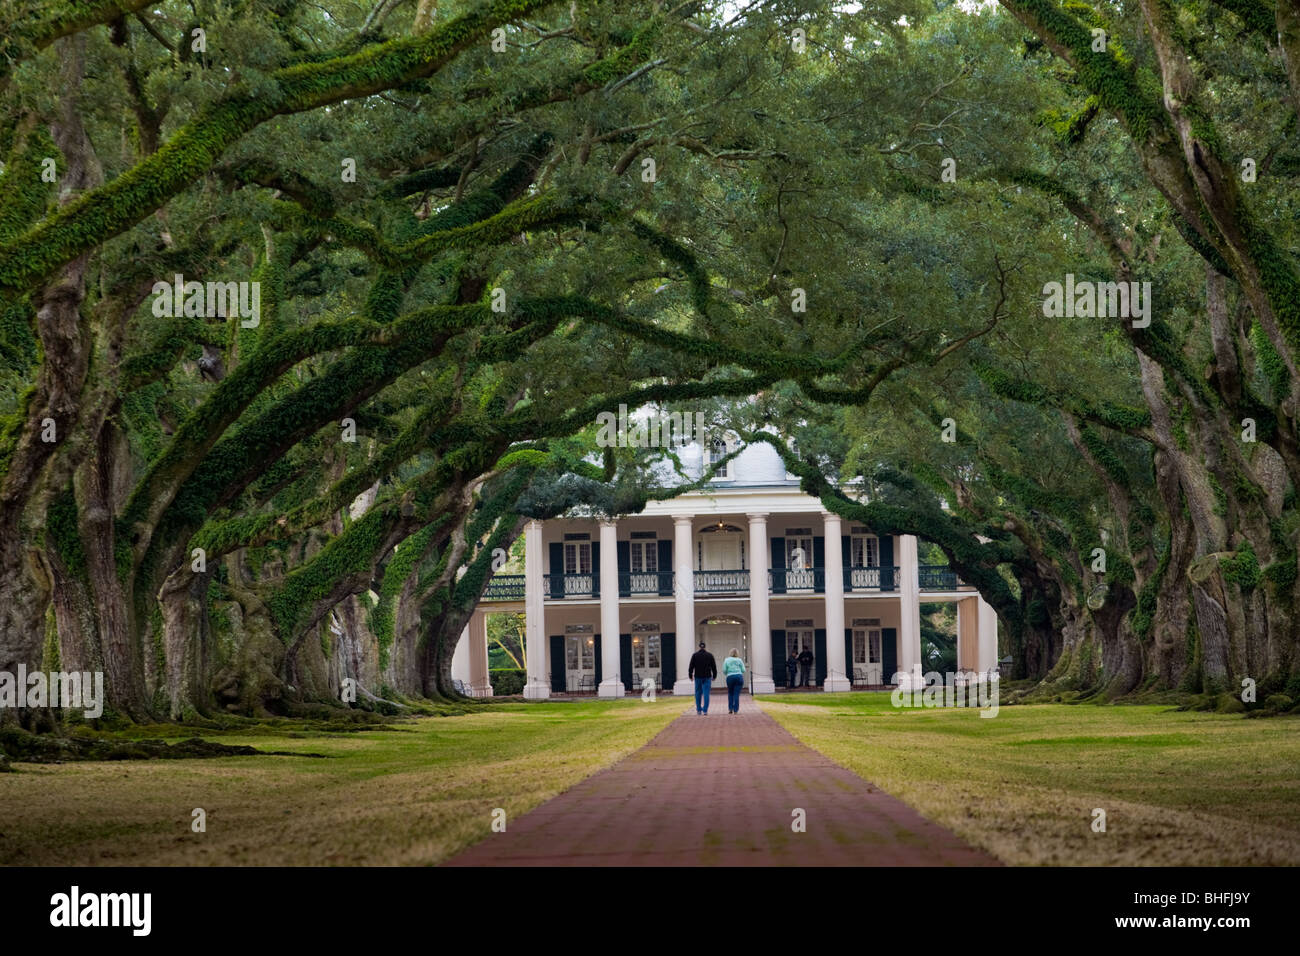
[{"xmin": 0, "ymin": 698, "xmax": 683, "ymax": 866}]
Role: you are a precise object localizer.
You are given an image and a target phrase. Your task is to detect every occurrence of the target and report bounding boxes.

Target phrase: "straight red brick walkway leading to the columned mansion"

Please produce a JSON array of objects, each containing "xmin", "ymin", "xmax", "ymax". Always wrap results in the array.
[{"xmin": 446, "ymin": 691, "xmax": 997, "ymax": 866}]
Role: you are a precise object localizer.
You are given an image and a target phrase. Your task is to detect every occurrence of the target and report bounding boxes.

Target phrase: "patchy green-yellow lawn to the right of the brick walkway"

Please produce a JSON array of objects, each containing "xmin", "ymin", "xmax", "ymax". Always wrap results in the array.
[{"xmin": 759, "ymin": 693, "xmax": 1300, "ymax": 866}]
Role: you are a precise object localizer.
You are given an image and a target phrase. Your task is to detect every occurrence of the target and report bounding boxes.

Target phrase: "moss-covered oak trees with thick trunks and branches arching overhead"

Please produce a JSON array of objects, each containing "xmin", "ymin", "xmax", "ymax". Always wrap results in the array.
[{"xmin": 0, "ymin": 0, "xmax": 1300, "ymax": 718}]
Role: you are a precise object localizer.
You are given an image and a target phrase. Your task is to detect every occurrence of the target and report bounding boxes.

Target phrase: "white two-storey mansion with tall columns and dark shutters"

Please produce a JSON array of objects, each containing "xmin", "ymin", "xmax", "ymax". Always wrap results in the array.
[{"xmin": 452, "ymin": 441, "xmax": 997, "ymax": 700}]
